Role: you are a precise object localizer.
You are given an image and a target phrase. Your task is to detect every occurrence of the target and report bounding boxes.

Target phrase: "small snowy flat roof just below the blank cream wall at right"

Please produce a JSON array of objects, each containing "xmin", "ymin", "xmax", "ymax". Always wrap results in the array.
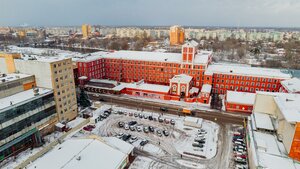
[{"xmin": 253, "ymin": 112, "xmax": 274, "ymax": 130}]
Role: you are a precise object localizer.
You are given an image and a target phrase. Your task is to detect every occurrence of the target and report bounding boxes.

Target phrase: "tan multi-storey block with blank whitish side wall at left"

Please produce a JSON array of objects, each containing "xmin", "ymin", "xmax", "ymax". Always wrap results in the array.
[{"xmin": 14, "ymin": 57, "xmax": 77, "ymax": 121}]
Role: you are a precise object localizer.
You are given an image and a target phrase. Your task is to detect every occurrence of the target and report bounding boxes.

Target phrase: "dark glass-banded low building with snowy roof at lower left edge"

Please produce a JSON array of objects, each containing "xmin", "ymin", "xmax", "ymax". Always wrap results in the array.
[{"xmin": 0, "ymin": 88, "xmax": 57, "ymax": 161}]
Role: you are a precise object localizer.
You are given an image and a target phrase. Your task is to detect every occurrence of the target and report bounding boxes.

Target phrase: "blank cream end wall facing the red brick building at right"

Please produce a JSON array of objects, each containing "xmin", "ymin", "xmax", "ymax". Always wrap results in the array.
[{"xmin": 253, "ymin": 93, "xmax": 276, "ymax": 115}]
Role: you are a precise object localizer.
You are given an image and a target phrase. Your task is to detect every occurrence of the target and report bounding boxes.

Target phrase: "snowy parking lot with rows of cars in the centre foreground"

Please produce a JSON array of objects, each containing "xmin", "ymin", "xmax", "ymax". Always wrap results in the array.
[{"xmin": 77, "ymin": 106, "xmax": 243, "ymax": 169}]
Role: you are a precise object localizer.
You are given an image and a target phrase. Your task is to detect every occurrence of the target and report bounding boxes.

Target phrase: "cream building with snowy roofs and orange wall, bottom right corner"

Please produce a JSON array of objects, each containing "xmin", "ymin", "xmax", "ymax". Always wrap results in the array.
[{"xmin": 247, "ymin": 92, "xmax": 300, "ymax": 169}]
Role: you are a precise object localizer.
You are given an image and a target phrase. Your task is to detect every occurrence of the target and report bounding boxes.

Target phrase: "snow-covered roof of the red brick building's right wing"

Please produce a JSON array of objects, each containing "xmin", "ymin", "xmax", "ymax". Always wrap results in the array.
[{"xmin": 206, "ymin": 64, "xmax": 291, "ymax": 79}]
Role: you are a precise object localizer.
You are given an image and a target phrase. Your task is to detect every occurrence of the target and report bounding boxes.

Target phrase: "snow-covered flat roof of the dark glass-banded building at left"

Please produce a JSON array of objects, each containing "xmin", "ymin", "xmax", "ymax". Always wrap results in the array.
[{"xmin": 0, "ymin": 88, "xmax": 52, "ymax": 110}]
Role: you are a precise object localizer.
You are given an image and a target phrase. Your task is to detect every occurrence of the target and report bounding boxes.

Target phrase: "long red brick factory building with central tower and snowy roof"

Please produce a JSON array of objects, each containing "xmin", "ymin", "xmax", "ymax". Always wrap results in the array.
[{"xmin": 75, "ymin": 41, "xmax": 291, "ymax": 104}]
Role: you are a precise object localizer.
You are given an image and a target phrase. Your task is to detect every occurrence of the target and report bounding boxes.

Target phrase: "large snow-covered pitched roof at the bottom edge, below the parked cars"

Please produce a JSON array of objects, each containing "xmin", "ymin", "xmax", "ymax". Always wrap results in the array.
[{"xmin": 27, "ymin": 139, "xmax": 127, "ymax": 169}]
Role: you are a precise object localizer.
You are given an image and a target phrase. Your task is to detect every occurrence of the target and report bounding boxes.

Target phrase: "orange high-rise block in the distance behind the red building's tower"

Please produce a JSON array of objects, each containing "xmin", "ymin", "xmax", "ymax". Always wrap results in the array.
[{"xmin": 170, "ymin": 25, "xmax": 184, "ymax": 46}]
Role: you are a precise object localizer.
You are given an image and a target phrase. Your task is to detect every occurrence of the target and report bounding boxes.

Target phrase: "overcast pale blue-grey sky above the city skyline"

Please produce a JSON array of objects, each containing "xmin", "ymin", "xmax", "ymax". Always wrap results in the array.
[{"xmin": 0, "ymin": 0, "xmax": 300, "ymax": 27}]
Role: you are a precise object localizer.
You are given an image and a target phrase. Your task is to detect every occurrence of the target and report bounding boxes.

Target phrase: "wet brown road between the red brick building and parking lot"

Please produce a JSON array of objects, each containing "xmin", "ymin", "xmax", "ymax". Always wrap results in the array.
[{"xmin": 87, "ymin": 92, "xmax": 247, "ymax": 125}]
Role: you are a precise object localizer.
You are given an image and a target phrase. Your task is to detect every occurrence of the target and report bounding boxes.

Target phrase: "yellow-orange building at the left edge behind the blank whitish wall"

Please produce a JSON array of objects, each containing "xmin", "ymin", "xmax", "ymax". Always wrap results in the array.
[{"xmin": 0, "ymin": 53, "xmax": 21, "ymax": 73}]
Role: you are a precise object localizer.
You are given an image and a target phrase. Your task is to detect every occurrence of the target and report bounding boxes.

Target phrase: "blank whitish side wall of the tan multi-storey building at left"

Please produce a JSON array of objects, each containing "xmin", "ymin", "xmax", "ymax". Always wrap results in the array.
[{"xmin": 15, "ymin": 59, "xmax": 53, "ymax": 89}]
